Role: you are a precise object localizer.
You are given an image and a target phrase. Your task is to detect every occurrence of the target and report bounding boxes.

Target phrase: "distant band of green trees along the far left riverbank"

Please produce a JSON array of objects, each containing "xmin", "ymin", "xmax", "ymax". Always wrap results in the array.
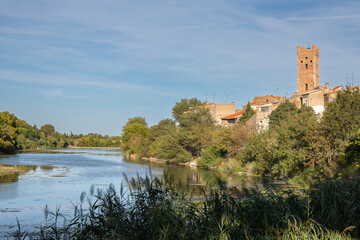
[{"xmin": 0, "ymin": 112, "xmax": 120, "ymax": 154}]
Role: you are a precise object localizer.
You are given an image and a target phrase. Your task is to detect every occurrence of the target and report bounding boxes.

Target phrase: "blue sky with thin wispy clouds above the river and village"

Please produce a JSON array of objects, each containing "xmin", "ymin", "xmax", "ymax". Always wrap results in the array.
[{"xmin": 0, "ymin": 0, "xmax": 360, "ymax": 136}]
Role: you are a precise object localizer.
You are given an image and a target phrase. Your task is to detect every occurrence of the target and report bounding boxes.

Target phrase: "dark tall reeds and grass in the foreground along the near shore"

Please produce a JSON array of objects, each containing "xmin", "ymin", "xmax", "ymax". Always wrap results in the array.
[{"xmin": 7, "ymin": 173, "xmax": 360, "ymax": 239}]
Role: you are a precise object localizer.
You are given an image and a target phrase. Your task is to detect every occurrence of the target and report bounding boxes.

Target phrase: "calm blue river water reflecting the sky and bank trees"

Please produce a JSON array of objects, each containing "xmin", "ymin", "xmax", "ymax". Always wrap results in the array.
[{"xmin": 0, "ymin": 149, "xmax": 278, "ymax": 238}]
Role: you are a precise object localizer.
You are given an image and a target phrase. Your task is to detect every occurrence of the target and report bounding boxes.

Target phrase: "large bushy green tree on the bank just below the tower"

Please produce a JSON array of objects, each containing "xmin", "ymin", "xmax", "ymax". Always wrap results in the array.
[{"xmin": 244, "ymin": 102, "xmax": 318, "ymax": 177}]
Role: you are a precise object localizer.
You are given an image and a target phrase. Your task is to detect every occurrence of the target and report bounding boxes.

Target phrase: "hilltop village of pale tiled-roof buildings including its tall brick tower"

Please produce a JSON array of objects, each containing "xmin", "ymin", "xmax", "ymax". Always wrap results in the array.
[{"xmin": 200, "ymin": 45, "xmax": 348, "ymax": 130}]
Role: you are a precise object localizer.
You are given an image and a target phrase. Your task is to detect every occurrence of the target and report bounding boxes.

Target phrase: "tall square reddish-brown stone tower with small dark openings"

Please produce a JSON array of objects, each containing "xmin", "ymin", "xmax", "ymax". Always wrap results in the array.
[{"xmin": 297, "ymin": 45, "xmax": 319, "ymax": 94}]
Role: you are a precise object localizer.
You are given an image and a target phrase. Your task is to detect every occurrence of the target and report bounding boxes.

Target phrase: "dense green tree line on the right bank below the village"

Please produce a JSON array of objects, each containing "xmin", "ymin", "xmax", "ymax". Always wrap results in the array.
[{"xmin": 122, "ymin": 89, "xmax": 360, "ymax": 184}]
